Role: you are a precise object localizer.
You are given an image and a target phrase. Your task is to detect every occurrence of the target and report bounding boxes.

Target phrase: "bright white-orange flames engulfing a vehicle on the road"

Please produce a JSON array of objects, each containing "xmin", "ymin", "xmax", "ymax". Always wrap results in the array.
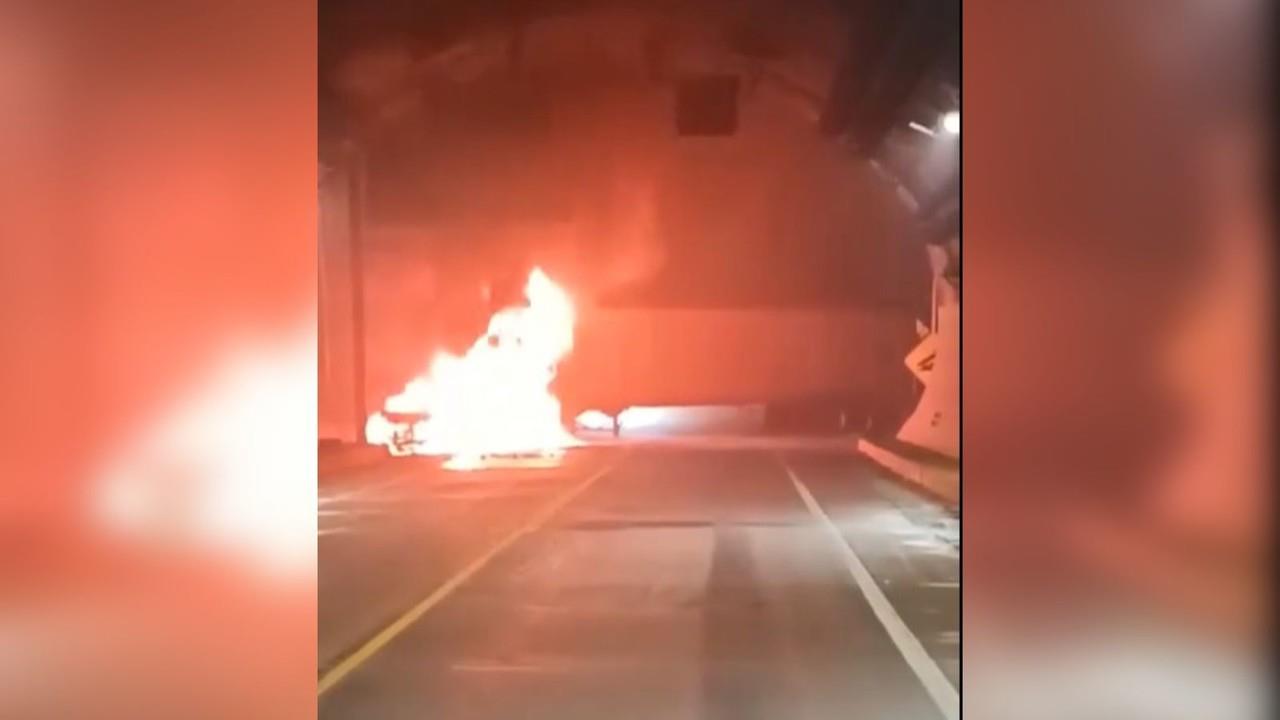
[{"xmin": 365, "ymin": 268, "xmax": 577, "ymax": 469}]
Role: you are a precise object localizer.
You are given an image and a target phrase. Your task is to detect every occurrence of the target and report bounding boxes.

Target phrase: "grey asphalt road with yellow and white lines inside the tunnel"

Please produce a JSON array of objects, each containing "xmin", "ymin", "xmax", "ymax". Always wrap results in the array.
[{"xmin": 319, "ymin": 446, "xmax": 960, "ymax": 720}]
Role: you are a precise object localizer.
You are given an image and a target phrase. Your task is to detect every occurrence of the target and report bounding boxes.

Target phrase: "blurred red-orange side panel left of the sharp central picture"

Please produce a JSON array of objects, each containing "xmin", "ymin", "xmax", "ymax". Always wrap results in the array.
[{"xmin": 0, "ymin": 0, "xmax": 316, "ymax": 717}]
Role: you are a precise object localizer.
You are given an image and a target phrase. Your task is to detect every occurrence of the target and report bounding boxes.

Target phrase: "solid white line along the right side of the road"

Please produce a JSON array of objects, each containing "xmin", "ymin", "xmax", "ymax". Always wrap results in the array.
[{"xmin": 778, "ymin": 455, "xmax": 960, "ymax": 720}]
